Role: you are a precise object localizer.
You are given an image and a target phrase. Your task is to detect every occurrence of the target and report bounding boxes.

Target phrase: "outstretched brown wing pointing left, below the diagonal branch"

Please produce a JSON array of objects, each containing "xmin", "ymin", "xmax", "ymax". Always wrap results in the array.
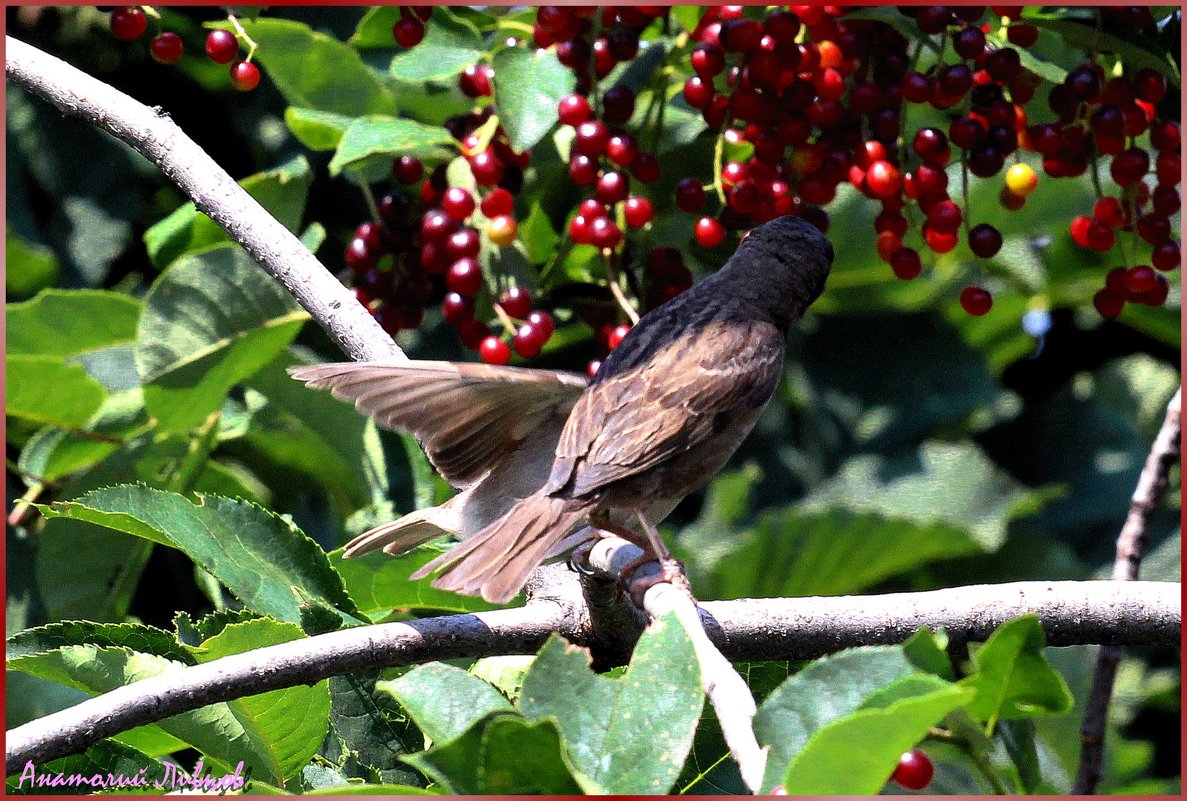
[{"xmin": 288, "ymin": 361, "xmax": 589, "ymax": 488}]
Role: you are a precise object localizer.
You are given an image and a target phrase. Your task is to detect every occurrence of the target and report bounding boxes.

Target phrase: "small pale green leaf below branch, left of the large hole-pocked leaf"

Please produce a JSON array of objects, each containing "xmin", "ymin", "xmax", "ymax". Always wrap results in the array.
[{"xmin": 376, "ymin": 662, "xmax": 512, "ymax": 744}]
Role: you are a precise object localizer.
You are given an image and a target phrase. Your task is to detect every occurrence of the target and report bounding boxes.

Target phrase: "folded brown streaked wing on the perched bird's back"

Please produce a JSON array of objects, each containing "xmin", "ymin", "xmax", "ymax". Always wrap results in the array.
[{"xmin": 547, "ymin": 320, "xmax": 785, "ymax": 497}]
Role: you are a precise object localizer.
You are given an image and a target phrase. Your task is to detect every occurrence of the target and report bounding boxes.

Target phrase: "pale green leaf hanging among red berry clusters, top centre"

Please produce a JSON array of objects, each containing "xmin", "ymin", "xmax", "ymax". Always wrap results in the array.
[{"xmin": 494, "ymin": 47, "xmax": 576, "ymax": 152}]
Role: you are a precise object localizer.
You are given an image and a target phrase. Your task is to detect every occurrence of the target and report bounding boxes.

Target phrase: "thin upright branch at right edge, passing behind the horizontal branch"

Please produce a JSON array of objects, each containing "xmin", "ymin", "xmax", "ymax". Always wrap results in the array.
[{"xmin": 1072, "ymin": 388, "xmax": 1182, "ymax": 795}]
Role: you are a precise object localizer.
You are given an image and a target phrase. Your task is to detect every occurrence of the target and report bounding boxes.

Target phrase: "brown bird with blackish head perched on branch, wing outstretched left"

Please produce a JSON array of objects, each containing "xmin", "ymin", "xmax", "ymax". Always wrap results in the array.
[{"xmin": 290, "ymin": 215, "xmax": 834, "ymax": 604}]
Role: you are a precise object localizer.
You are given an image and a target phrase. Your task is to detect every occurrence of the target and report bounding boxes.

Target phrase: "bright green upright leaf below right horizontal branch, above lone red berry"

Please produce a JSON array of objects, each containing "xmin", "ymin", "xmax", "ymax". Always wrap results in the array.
[{"xmin": 960, "ymin": 615, "xmax": 1073, "ymax": 730}]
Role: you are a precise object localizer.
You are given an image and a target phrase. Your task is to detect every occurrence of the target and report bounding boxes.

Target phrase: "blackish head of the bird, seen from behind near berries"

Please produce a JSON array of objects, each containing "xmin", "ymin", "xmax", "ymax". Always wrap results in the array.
[{"xmin": 718, "ymin": 215, "xmax": 833, "ymax": 330}]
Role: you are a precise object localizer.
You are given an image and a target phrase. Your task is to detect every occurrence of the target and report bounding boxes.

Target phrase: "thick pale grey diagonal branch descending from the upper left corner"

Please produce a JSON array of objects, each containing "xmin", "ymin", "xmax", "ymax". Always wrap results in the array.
[{"xmin": 5, "ymin": 37, "xmax": 404, "ymax": 361}]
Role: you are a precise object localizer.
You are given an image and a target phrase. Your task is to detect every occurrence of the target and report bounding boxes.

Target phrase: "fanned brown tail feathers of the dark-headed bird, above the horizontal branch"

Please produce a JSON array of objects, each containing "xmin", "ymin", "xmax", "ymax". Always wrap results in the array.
[{"xmin": 412, "ymin": 490, "xmax": 594, "ymax": 604}]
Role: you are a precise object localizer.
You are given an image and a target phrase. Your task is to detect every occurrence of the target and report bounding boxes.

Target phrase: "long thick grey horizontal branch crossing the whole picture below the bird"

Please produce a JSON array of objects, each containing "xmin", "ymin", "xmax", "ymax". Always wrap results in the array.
[{"xmin": 5, "ymin": 581, "xmax": 1181, "ymax": 773}]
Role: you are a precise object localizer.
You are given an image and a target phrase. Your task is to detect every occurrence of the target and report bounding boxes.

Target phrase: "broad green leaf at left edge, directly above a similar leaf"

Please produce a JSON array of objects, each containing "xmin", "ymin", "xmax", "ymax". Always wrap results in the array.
[{"xmin": 5, "ymin": 290, "xmax": 140, "ymax": 358}]
